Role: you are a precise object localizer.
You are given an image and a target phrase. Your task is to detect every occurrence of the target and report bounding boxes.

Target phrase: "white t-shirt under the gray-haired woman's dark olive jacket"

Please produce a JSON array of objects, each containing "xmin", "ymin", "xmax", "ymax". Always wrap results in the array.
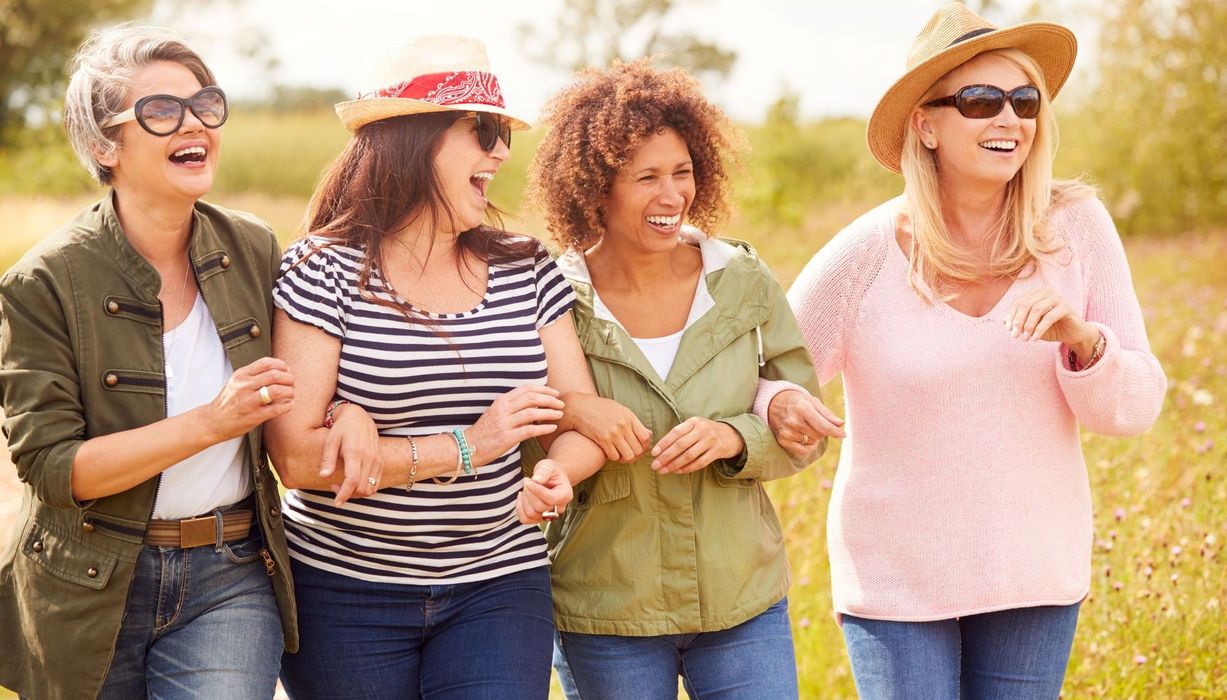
[{"xmin": 153, "ymin": 294, "xmax": 252, "ymax": 519}]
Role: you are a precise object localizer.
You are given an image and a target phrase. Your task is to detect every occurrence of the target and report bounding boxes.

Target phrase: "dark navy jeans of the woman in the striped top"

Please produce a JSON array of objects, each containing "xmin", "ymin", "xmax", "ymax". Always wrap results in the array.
[{"xmin": 281, "ymin": 561, "xmax": 553, "ymax": 700}]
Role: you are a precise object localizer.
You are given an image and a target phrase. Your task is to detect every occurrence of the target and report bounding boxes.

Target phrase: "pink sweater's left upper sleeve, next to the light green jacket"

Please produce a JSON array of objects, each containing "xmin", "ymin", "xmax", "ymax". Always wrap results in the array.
[{"xmin": 788, "ymin": 208, "xmax": 886, "ymax": 384}]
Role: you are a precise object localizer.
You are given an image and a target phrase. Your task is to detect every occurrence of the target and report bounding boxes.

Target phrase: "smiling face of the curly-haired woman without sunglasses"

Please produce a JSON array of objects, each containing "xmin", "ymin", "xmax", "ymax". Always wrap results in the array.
[{"xmin": 602, "ymin": 126, "xmax": 694, "ymax": 252}]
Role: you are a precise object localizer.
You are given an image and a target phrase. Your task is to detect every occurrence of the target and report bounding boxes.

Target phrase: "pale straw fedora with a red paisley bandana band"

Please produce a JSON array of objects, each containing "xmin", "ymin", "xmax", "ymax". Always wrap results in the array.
[{"xmin": 336, "ymin": 34, "xmax": 531, "ymax": 131}]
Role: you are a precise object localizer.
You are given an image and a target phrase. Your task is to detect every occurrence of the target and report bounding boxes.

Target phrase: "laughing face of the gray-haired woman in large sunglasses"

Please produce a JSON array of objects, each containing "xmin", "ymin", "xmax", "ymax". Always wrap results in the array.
[{"xmin": 98, "ymin": 61, "xmax": 222, "ymax": 203}]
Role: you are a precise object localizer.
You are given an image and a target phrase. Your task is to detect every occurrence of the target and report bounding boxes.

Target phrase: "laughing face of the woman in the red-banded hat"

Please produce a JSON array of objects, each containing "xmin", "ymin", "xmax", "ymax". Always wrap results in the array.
[{"xmin": 434, "ymin": 117, "xmax": 510, "ymax": 233}]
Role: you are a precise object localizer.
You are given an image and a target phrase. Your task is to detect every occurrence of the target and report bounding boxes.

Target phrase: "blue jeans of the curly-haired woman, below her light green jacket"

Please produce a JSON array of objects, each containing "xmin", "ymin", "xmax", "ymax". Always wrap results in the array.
[{"xmin": 553, "ymin": 598, "xmax": 796, "ymax": 700}]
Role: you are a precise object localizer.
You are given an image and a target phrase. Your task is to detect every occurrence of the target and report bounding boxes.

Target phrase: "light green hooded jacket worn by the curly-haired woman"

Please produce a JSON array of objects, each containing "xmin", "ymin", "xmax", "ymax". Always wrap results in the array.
[{"xmin": 525, "ymin": 233, "xmax": 818, "ymax": 636}]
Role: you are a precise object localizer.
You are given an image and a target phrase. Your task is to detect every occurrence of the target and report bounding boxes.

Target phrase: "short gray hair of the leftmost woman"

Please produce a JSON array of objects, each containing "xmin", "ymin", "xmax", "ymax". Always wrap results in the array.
[{"xmin": 64, "ymin": 22, "xmax": 217, "ymax": 184}]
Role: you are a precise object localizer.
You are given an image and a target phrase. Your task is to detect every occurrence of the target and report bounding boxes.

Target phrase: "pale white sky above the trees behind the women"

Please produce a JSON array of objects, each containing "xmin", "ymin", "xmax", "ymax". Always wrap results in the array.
[{"xmin": 152, "ymin": 0, "xmax": 1098, "ymax": 122}]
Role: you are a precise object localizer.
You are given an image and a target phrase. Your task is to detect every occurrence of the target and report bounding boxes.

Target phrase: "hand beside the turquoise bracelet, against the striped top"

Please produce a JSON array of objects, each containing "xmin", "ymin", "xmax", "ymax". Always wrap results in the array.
[{"xmin": 465, "ymin": 384, "xmax": 563, "ymax": 467}]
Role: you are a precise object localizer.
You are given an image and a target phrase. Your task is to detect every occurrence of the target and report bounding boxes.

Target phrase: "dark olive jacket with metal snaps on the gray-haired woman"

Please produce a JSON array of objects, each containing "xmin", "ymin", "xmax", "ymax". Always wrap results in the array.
[{"xmin": 0, "ymin": 196, "xmax": 298, "ymax": 698}]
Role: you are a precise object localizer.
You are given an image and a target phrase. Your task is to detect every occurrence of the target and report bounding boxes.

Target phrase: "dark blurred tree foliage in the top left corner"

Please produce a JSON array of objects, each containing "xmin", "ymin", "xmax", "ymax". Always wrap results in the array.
[{"xmin": 0, "ymin": 0, "xmax": 151, "ymax": 147}]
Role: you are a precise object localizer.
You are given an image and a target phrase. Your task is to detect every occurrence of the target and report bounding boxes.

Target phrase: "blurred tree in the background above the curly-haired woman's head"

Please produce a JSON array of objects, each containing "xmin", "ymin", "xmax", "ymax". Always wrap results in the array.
[{"xmin": 520, "ymin": 0, "xmax": 737, "ymax": 77}]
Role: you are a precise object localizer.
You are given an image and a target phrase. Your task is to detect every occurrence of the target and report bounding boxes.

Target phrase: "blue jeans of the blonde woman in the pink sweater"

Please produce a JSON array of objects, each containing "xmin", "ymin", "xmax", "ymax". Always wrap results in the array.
[{"xmin": 843, "ymin": 603, "xmax": 1079, "ymax": 700}]
